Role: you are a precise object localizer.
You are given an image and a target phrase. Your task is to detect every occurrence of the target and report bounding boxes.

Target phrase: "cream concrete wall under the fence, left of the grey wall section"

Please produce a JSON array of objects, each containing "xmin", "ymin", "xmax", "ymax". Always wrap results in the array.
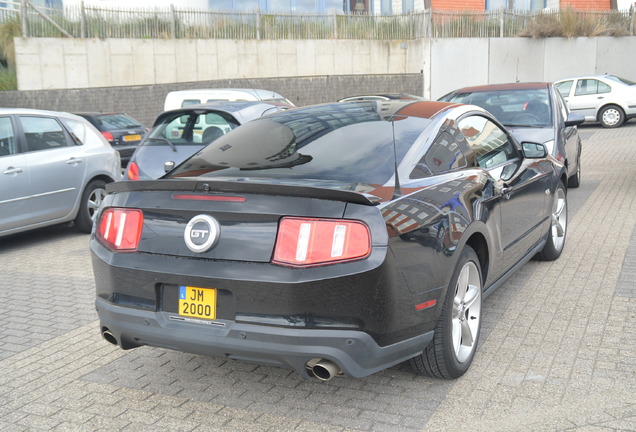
[{"xmin": 15, "ymin": 38, "xmax": 422, "ymax": 90}]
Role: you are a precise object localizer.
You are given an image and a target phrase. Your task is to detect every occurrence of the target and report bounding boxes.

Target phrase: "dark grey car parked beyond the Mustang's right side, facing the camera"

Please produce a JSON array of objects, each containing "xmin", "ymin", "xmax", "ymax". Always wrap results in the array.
[{"xmin": 440, "ymin": 82, "xmax": 584, "ymax": 188}]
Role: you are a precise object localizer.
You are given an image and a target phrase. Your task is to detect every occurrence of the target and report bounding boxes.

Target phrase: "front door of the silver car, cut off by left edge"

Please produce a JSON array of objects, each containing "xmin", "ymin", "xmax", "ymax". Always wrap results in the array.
[{"xmin": 0, "ymin": 116, "xmax": 30, "ymax": 232}]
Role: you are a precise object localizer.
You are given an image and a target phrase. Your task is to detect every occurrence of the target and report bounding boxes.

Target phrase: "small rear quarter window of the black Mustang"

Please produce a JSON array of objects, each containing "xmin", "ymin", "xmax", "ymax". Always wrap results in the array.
[{"xmin": 410, "ymin": 130, "xmax": 466, "ymax": 179}]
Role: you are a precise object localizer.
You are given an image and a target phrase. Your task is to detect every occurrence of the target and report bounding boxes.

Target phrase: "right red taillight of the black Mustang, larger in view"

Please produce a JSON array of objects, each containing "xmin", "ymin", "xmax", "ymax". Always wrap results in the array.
[{"xmin": 272, "ymin": 217, "xmax": 371, "ymax": 266}]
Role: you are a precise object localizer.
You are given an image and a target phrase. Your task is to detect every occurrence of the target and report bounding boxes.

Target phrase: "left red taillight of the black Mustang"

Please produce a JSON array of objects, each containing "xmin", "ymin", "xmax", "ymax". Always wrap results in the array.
[{"xmin": 96, "ymin": 208, "xmax": 144, "ymax": 252}]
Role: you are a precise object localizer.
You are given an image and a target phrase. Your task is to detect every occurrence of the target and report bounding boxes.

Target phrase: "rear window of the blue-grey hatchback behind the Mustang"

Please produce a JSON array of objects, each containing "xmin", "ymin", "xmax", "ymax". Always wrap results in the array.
[{"xmin": 142, "ymin": 110, "xmax": 238, "ymax": 147}]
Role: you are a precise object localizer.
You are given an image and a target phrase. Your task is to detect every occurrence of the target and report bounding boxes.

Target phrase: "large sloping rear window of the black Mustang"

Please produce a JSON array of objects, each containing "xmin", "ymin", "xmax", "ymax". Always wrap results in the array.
[{"xmin": 170, "ymin": 102, "xmax": 430, "ymax": 185}]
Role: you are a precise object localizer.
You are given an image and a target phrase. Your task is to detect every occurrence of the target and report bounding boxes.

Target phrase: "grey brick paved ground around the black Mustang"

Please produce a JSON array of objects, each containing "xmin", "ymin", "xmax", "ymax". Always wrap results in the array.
[{"xmin": 0, "ymin": 121, "xmax": 636, "ymax": 432}]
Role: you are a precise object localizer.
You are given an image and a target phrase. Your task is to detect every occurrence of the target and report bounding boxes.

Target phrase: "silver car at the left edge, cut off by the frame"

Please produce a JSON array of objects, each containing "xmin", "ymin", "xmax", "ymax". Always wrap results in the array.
[{"xmin": 0, "ymin": 108, "xmax": 121, "ymax": 237}]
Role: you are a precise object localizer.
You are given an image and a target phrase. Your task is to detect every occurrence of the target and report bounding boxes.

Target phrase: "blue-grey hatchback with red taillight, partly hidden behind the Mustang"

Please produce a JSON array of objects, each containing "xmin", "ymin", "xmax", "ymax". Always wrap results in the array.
[{"xmin": 125, "ymin": 101, "xmax": 293, "ymax": 180}]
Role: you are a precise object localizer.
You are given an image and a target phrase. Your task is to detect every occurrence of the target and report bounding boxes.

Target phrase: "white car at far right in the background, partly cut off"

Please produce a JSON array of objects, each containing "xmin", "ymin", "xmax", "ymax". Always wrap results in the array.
[{"xmin": 554, "ymin": 75, "xmax": 636, "ymax": 128}]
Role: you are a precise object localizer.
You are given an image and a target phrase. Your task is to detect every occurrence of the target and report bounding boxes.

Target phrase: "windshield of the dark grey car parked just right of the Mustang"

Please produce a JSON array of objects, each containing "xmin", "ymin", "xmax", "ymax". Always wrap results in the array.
[{"xmin": 444, "ymin": 88, "xmax": 552, "ymax": 127}]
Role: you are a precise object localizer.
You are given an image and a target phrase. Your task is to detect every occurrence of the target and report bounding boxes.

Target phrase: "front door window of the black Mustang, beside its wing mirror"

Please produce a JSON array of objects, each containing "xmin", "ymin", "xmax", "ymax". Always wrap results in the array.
[{"xmin": 458, "ymin": 115, "xmax": 519, "ymax": 169}]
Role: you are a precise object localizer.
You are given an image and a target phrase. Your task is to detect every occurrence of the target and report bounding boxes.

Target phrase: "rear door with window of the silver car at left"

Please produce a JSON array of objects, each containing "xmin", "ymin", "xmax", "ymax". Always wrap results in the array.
[{"xmin": 18, "ymin": 115, "xmax": 87, "ymax": 224}]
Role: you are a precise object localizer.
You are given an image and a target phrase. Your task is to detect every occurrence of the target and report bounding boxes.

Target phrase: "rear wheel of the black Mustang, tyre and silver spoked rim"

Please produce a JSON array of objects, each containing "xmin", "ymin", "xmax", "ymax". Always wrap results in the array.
[{"xmin": 410, "ymin": 246, "xmax": 483, "ymax": 378}]
